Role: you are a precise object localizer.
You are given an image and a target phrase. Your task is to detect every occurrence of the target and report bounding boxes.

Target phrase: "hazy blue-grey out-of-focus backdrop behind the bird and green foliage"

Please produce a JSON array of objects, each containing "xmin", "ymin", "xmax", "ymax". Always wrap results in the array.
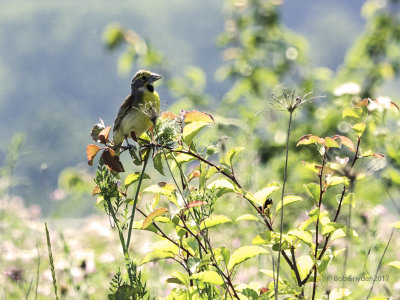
[{"xmin": 0, "ymin": 0, "xmax": 374, "ymax": 215}]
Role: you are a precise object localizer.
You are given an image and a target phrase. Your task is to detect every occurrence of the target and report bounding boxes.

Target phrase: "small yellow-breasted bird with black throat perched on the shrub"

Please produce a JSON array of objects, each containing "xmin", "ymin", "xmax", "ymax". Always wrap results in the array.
[{"xmin": 113, "ymin": 70, "xmax": 161, "ymax": 146}]
